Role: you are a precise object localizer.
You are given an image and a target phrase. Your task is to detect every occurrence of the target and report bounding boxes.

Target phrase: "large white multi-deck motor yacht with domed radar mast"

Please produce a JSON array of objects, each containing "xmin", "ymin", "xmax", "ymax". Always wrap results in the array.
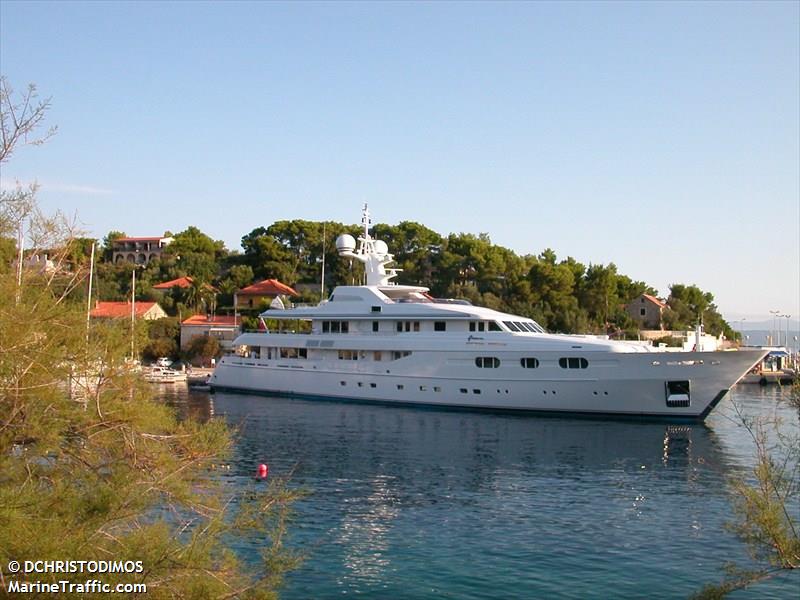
[{"xmin": 210, "ymin": 206, "xmax": 765, "ymax": 420}]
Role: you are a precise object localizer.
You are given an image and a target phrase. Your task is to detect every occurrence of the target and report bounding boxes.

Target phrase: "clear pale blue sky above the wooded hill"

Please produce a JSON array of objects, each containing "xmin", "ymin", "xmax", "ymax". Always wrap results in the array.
[{"xmin": 0, "ymin": 0, "xmax": 800, "ymax": 320}]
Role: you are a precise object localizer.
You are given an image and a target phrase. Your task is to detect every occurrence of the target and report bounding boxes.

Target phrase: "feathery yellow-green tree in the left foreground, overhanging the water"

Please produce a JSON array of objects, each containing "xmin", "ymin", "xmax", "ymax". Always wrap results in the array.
[{"xmin": 0, "ymin": 79, "xmax": 297, "ymax": 598}]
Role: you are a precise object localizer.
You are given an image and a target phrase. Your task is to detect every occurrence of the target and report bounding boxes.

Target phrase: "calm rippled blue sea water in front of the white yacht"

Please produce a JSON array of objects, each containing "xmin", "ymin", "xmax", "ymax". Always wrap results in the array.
[{"xmin": 163, "ymin": 386, "xmax": 800, "ymax": 599}]
